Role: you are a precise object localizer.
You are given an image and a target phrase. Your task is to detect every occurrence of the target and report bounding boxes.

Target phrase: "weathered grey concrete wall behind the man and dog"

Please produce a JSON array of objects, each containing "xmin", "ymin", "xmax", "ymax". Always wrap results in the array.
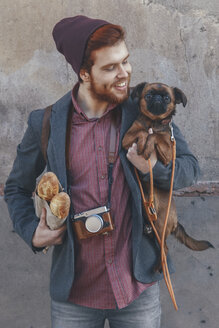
[{"xmin": 0, "ymin": 0, "xmax": 219, "ymax": 328}]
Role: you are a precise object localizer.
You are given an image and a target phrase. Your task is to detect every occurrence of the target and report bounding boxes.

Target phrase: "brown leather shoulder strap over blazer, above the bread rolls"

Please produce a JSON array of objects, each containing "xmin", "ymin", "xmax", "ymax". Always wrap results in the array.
[{"xmin": 41, "ymin": 105, "xmax": 53, "ymax": 162}]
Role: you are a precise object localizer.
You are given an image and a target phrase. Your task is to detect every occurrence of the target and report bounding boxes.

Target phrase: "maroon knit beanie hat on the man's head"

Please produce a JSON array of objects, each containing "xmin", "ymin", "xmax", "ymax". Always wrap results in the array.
[{"xmin": 52, "ymin": 15, "xmax": 110, "ymax": 74}]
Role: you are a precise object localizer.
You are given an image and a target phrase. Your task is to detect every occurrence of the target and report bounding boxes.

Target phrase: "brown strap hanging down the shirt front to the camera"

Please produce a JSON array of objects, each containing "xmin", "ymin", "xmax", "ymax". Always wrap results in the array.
[{"xmin": 107, "ymin": 120, "xmax": 116, "ymax": 208}]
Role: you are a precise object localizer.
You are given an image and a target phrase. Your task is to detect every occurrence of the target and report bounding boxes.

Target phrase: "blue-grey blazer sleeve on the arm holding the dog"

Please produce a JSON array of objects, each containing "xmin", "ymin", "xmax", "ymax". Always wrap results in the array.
[{"xmin": 142, "ymin": 123, "xmax": 200, "ymax": 190}]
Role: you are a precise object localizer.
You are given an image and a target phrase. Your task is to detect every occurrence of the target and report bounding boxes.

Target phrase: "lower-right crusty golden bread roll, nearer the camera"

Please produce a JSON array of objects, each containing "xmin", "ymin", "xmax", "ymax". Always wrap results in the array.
[{"xmin": 50, "ymin": 192, "xmax": 70, "ymax": 219}]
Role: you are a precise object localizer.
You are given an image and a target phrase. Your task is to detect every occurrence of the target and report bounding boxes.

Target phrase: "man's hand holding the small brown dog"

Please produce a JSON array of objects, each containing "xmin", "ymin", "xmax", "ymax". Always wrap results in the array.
[{"xmin": 126, "ymin": 143, "xmax": 157, "ymax": 174}]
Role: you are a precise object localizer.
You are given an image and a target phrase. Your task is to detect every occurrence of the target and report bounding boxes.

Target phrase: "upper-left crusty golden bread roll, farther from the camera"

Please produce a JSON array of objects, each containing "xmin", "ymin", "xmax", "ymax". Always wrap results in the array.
[{"xmin": 37, "ymin": 172, "xmax": 59, "ymax": 201}]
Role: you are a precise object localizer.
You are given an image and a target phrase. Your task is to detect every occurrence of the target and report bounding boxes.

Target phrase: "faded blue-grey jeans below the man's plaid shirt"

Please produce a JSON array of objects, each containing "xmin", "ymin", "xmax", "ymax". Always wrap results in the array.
[{"xmin": 51, "ymin": 283, "xmax": 161, "ymax": 328}]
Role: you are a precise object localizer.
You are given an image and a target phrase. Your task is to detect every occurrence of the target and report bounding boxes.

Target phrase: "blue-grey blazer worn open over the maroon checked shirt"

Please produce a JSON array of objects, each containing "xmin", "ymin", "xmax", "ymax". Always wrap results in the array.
[{"xmin": 5, "ymin": 92, "xmax": 199, "ymax": 301}]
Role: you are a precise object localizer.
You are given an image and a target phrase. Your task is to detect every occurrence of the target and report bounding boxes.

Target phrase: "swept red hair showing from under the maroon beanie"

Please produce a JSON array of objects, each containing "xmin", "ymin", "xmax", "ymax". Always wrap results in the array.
[{"xmin": 81, "ymin": 24, "xmax": 125, "ymax": 73}]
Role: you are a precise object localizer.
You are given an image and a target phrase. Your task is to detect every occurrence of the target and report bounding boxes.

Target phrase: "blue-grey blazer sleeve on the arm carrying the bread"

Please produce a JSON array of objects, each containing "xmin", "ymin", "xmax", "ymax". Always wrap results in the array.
[{"xmin": 4, "ymin": 110, "xmax": 46, "ymax": 251}]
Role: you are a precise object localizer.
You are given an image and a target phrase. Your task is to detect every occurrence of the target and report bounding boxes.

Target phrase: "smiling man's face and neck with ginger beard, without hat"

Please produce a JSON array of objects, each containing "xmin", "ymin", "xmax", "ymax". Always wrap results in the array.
[{"xmin": 77, "ymin": 38, "xmax": 131, "ymax": 117}]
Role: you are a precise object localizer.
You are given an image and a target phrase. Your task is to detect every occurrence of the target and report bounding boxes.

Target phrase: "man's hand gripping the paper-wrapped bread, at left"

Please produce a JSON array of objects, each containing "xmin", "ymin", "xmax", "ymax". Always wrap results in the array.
[{"xmin": 32, "ymin": 208, "xmax": 66, "ymax": 248}]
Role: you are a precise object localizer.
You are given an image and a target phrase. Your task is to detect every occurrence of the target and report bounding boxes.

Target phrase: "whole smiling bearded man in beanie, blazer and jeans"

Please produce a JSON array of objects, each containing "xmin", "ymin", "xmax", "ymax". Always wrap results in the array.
[{"xmin": 5, "ymin": 16, "xmax": 199, "ymax": 328}]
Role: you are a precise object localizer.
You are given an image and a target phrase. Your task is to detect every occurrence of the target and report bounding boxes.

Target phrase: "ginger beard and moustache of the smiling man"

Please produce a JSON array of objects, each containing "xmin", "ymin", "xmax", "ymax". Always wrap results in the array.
[{"xmin": 90, "ymin": 74, "xmax": 130, "ymax": 104}]
